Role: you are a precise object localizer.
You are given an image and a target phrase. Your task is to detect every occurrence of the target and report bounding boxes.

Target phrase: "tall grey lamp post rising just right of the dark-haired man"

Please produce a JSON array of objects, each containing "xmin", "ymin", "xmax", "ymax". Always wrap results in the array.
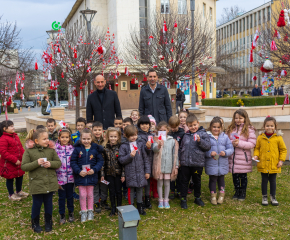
[{"xmin": 189, "ymin": 0, "xmax": 199, "ymax": 110}]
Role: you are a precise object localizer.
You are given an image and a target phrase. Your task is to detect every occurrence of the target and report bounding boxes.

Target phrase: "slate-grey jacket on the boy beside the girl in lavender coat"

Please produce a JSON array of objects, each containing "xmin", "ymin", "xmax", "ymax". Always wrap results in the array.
[{"xmin": 179, "ymin": 127, "xmax": 211, "ymax": 167}]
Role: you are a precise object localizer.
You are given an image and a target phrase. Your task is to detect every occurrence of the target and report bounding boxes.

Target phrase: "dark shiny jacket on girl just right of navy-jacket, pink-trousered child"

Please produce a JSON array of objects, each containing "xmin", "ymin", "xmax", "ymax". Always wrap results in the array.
[{"xmin": 101, "ymin": 143, "xmax": 125, "ymax": 177}]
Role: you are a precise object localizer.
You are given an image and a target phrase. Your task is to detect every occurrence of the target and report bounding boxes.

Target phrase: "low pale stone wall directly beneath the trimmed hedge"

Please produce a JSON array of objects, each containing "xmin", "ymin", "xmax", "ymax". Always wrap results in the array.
[{"xmin": 200, "ymin": 105, "xmax": 290, "ymax": 118}]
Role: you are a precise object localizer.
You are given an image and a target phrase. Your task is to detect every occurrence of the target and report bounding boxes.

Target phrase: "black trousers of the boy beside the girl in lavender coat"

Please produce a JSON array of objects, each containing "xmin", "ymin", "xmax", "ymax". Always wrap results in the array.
[{"xmin": 179, "ymin": 166, "xmax": 203, "ymax": 199}]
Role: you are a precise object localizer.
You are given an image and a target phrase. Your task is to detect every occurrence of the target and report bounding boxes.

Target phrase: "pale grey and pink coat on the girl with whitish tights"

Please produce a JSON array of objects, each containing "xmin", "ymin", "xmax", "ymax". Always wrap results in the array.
[{"xmin": 152, "ymin": 136, "xmax": 179, "ymax": 181}]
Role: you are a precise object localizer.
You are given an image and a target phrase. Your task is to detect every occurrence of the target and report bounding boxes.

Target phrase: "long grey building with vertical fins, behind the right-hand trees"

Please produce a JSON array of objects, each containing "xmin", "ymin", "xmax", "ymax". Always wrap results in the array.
[{"xmin": 216, "ymin": 1, "xmax": 274, "ymax": 92}]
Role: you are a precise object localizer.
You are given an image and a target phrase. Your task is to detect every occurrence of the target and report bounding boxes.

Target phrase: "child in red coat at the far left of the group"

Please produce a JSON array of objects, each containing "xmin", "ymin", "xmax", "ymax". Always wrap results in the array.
[{"xmin": 0, "ymin": 120, "xmax": 29, "ymax": 201}]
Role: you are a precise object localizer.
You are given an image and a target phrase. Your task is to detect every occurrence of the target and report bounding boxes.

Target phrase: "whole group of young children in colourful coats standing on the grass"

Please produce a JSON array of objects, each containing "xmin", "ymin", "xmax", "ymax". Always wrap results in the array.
[{"xmin": 0, "ymin": 109, "xmax": 287, "ymax": 233}]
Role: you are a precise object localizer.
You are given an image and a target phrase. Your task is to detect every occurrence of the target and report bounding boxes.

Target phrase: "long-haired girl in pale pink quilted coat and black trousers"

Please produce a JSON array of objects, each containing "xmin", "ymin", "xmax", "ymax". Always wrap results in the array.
[{"xmin": 227, "ymin": 109, "xmax": 256, "ymax": 201}]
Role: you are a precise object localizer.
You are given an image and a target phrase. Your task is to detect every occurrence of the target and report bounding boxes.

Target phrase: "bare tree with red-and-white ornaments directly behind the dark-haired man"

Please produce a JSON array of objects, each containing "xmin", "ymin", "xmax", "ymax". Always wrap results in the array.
[{"xmin": 122, "ymin": 6, "xmax": 215, "ymax": 112}]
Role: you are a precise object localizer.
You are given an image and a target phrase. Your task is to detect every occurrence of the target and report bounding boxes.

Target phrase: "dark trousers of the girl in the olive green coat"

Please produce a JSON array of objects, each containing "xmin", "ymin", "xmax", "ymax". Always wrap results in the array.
[{"xmin": 31, "ymin": 192, "xmax": 53, "ymax": 219}]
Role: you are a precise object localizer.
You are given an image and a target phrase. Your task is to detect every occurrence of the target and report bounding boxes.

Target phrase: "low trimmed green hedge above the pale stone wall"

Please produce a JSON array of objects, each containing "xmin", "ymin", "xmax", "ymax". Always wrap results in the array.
[{"xmin": 201, "ymin": 96, "xmax": 285, "ymax": 107}]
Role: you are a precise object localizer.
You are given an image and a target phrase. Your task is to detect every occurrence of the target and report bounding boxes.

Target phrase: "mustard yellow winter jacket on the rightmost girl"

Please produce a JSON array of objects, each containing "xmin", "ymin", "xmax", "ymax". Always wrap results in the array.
[{"xmin": 254, "ymin": 131, "xmax": 287, "ymax": 174}]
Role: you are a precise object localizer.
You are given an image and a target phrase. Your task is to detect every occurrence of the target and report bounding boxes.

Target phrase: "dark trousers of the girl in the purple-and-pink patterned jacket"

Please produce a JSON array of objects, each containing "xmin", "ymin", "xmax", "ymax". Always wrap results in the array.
[{"xmin": 58, "ymin": 183, "xmax": 74, "ymax": 214}]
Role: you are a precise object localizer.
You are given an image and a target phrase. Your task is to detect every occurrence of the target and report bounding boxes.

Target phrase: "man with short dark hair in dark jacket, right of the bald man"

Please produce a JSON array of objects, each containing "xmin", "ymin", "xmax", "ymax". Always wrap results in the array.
[{"xmin": 139, "ymin": 69, "xmax": 172, "ymax": 124}]
